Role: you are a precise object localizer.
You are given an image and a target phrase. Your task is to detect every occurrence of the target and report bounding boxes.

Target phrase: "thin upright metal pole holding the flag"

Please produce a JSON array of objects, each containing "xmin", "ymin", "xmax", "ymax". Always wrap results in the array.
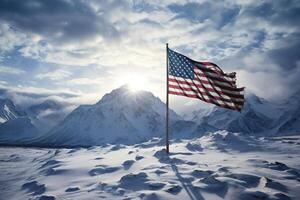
[{"xmin": 166, "ymin": 43, "xmax": 169, "ymax": 153}]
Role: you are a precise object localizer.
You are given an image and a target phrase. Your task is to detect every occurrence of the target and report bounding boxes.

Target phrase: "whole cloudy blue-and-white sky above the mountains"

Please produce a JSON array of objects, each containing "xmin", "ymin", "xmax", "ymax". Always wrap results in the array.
[{"xmin": 0, "ymin": 0, "xmax": 300, "ymax": 112}]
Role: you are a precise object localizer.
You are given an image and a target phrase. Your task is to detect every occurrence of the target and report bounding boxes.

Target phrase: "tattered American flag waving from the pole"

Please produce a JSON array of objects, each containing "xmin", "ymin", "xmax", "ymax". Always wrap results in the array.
[{"xmin": 168, "ymin": 48, "xmax": 245, "ymax": 111}]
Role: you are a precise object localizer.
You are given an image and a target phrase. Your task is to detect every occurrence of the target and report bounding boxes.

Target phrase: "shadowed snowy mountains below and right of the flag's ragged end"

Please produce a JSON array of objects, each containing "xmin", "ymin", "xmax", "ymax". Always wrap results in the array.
[{"xmin": 191, "ymin": 94, "xmax": 300, "ymax": 135}]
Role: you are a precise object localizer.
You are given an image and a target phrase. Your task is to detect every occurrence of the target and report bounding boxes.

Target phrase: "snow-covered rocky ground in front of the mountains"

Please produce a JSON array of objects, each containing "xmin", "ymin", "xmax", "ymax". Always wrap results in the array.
[{"xmin": 0, "ymin": 132, "xmax": 300, "ymax": 200}]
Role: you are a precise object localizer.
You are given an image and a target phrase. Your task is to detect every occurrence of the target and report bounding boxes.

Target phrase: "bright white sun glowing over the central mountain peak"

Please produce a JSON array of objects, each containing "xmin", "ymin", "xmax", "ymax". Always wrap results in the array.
[{"xmin": 123, "ymin": 75, "xmax": 149, "ymax": 92}]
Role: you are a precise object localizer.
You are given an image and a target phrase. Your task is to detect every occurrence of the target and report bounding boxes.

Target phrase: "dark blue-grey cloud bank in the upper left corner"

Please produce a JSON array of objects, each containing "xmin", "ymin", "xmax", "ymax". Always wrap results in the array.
[{"xmin": 0, "ymin": 0, "xmax": 119, "ymax": 42}]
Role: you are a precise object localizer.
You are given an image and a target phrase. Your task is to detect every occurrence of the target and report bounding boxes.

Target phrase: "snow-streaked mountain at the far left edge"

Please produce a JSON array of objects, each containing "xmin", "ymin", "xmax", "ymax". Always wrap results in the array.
[{"xmin": 0, "ymin": 99, "xmax": 38, "ymax": 144}]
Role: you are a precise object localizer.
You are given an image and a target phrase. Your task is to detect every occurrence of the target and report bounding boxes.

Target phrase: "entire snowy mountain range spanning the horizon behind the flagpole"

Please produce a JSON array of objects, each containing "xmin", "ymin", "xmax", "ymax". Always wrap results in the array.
[{"xmin": 0, "ymin": 86, "xmax": 300, "ymax": 146}]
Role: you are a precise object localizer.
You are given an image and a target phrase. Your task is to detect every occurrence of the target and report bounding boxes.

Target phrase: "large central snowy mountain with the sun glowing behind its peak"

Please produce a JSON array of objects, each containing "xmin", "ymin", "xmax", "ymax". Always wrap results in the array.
[{"xmin": 37, "ymin": 86, "xmax": 196, "ymax": 146}]
